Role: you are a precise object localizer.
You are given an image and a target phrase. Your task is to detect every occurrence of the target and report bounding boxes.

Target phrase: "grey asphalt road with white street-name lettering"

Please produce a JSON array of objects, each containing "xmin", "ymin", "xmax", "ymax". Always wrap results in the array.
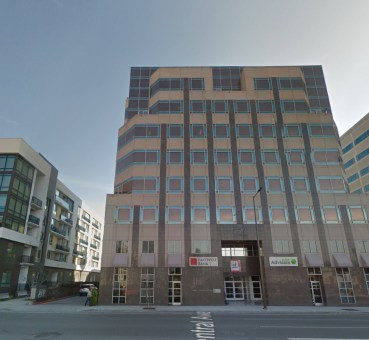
[{"xmin": 0, "ymin": 310, "xmax": 369, "ymax": 340}]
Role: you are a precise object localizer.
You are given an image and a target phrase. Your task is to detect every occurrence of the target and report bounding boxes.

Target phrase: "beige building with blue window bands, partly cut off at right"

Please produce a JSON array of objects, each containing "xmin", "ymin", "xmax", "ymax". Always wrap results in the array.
[{"xmin": 341, "ymin": 114, "xmax": 369, "ymax": 193}]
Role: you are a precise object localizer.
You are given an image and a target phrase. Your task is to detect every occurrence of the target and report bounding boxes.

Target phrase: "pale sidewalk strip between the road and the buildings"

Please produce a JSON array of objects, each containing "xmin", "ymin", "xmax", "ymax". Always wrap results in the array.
[{"xmin": 0, "ymin": 296, "xmax": 369, "ymax": 314}]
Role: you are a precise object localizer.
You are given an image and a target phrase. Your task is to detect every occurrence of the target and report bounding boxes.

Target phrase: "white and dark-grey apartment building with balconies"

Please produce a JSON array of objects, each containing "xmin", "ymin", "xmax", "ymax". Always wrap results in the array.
[{"xmin": 0, "ymin": 138, "xmax": 103, "ymax": 296}]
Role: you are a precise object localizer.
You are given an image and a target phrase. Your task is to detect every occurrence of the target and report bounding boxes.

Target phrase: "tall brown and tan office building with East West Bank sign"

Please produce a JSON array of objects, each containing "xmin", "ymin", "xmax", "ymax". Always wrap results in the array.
[{"xmin": 100, "ymin": 66, "xmax": 369, "ymax": 305}]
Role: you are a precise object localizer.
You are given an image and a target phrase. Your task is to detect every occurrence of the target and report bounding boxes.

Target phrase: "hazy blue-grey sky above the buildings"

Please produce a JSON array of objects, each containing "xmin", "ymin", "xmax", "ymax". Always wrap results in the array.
[{"xmin": 0, "ymin": 0, "xmax": 369, "ymax": 216}]
